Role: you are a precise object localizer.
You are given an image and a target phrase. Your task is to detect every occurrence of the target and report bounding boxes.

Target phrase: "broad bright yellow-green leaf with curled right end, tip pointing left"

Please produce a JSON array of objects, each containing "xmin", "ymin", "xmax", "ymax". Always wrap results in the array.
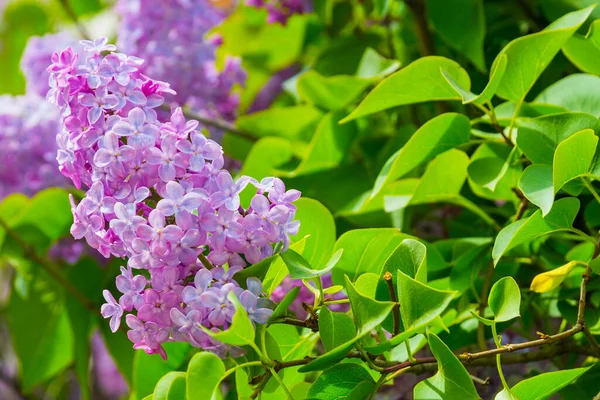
[{"xmin": 341, "ymin": 56, "xmax": 471, "ymax": 123}]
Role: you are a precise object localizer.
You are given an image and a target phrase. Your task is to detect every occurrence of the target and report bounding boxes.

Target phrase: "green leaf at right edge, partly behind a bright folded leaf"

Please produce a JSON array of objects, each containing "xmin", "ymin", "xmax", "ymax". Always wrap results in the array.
[{"xmin": 517, "ymin": 112, "xmax": 600, "ymax": 165}]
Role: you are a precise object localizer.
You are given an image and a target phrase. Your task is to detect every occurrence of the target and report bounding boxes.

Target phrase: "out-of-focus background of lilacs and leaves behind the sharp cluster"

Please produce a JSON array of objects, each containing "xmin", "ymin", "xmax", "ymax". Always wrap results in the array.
[{"xmin": 0, "ymin": 0, "xmax": 600, "ymax": 400}]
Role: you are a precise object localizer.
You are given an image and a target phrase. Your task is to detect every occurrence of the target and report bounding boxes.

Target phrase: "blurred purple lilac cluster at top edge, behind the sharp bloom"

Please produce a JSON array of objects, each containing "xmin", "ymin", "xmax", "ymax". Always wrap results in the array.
[{"xmin": 115, "ymin": 0, "xmax": 246, "ymax": 124}]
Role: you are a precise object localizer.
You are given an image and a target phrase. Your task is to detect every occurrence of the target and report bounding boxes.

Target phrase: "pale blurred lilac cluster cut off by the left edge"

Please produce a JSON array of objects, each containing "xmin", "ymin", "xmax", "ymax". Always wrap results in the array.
[{"xmin": 0, "ymin": 95, "xmax": 67, "ymax": 199}]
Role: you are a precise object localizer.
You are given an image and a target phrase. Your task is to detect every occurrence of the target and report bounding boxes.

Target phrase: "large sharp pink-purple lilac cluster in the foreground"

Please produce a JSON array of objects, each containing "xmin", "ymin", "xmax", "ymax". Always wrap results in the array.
[{"xmin": 48, "ymin": 39, "xmax": 300, "ymax": 357}]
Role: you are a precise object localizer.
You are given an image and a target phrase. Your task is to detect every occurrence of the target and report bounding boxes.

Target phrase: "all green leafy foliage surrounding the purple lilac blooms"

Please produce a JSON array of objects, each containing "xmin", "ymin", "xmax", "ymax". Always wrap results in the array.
[{"xmin": 0, "ymin": 0, "xmax": 600, "ymax": 400}]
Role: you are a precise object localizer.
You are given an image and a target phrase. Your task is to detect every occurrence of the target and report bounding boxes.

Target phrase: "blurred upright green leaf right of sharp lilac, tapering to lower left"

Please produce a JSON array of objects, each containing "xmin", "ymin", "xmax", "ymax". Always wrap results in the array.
[{"xmin": 279, "ymin": 113, "xmax": 357, "ymax": 178}]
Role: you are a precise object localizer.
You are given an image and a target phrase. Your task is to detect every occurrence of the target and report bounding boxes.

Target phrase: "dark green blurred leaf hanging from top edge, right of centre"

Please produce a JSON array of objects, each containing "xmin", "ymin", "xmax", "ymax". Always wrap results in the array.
[{"xmin": 427, "ymin": 0, "xmax": 486, "ymax": 71}]
